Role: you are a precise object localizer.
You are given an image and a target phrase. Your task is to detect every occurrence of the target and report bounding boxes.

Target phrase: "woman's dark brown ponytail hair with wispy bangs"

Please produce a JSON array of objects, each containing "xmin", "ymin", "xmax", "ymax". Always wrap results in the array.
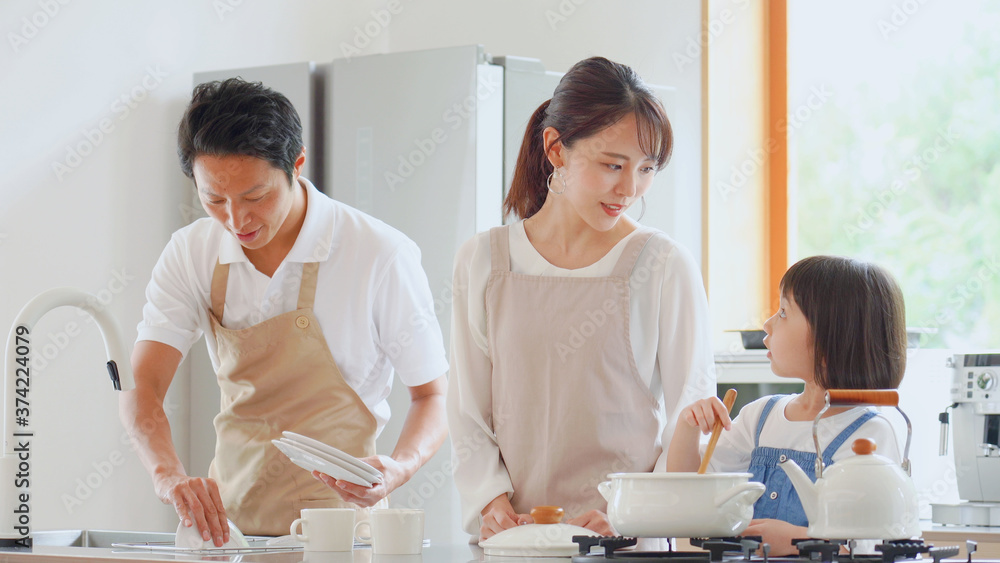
[{"xmin": 503, "ymin": 57, "xmax": 674, "ymax": 219}]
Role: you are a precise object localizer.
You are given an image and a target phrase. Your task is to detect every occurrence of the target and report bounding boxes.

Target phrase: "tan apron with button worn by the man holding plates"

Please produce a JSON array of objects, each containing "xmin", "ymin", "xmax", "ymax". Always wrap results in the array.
[{"xmin": 209, "ymin": 262, "xmax": 376, "ymax": 536}]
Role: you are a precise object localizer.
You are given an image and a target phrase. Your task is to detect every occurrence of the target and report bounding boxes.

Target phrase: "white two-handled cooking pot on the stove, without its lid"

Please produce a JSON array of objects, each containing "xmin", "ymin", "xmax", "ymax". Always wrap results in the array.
[{"xmin": 597, "ymin": 473, "xmax": 765, "ymax": 538}]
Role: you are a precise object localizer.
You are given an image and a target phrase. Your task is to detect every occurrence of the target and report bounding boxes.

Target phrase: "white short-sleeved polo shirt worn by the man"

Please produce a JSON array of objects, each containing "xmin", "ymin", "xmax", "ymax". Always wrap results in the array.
[{"xmin": 137, "ymin": 178, "xmax": 448, "ymax": 432}]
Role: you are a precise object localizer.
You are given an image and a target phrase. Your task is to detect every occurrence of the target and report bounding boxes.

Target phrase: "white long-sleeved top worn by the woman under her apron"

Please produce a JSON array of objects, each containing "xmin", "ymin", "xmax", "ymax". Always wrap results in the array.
[{"xmin": 448, "ymin": 222, "xmax": 716, "ymax": 534}]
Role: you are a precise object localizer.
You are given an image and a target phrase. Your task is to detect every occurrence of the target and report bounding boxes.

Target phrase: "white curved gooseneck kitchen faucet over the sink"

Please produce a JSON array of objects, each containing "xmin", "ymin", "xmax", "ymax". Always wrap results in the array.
[{"xmin": 0, "ymin": 287, "xmax": 135, "ymax": 546}]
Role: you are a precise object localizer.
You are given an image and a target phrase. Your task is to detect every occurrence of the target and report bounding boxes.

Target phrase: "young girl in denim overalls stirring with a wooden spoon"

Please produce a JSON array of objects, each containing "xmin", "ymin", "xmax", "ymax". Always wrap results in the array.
[{"xmin": 667, "ymin": 256, "xmax": 906, "ymax": 555}]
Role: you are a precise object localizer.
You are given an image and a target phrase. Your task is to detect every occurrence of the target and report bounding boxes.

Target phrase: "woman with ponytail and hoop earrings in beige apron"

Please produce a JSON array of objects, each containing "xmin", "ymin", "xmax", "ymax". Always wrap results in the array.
[{"xmin": 448, "ymin": 57, "xmax": 716, "ymax": 539}]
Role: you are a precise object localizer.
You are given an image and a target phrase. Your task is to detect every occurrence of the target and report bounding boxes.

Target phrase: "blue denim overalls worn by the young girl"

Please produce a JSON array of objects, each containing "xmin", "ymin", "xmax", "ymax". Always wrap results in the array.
[{"xmin": 749, "ymin": 395, "xmax": 878, "ymax": 526}]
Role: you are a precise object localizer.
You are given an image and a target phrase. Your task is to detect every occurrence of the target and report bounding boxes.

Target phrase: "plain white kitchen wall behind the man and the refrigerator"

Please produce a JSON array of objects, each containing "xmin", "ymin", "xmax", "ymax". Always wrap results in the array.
[{"xmin": 0, "ymin": 0, "xmax": 701, "ymax": 531}]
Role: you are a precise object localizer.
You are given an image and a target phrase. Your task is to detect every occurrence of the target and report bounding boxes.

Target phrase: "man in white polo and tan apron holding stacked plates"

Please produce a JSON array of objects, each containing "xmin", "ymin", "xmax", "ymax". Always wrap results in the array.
[{"xmin": 121, "ymin": 79, "xmax": 448, "ymax": 546}]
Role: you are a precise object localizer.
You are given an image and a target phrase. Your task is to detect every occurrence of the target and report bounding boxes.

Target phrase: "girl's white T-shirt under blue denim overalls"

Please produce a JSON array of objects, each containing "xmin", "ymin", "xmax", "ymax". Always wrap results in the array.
[{"xmin": 702, "ymin": 395, "xmax": 903, "ymax": 472}]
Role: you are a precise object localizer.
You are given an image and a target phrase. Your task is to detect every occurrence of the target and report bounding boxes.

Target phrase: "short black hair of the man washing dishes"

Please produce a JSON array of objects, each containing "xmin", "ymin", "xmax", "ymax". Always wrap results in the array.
[{"xmin": 177, "ymin": 78, "xmax": 303, "ymax": 182}]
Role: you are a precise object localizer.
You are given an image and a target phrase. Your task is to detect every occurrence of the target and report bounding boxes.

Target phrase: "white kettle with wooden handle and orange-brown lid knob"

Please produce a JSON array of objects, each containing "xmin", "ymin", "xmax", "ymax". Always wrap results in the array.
[{"xmin": 778, "ymin": 390, "xmax": 920, "ymax": 540}]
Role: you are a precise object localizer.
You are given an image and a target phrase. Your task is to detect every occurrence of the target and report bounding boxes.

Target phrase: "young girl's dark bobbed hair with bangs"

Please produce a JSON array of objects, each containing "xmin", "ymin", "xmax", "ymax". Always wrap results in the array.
[{"xmin": 780, "ymin": 256, "xmax": 906, "ymax": 389}]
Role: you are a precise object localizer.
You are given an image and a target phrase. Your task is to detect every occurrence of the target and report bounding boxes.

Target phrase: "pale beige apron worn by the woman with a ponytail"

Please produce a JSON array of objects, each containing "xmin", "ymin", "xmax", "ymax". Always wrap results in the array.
[{"xmin": 486, "ymin": 226, "xmax": 661, "ymax": 517}]
